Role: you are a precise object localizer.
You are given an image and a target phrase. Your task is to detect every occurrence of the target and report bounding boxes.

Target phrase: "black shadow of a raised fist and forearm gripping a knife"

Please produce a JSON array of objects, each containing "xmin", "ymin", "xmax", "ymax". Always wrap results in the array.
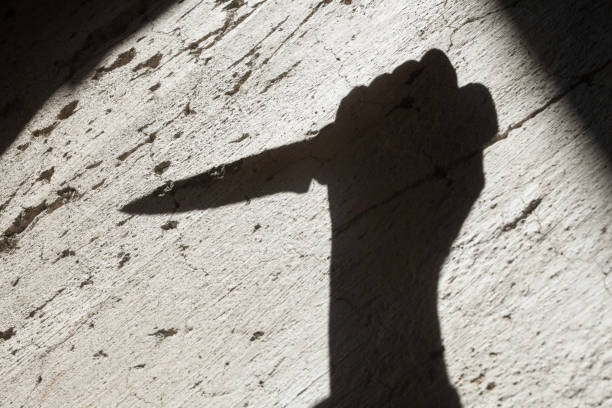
[{"xmin": 122, "ymin": 50, "xmax": 497, "ymax": 407}]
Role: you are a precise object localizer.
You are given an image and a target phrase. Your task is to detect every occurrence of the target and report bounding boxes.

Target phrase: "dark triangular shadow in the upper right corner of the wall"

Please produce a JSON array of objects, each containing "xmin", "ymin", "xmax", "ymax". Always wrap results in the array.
[{"xmin": 498, "ymin": 0, "xmax": 612, "ymax": 155}]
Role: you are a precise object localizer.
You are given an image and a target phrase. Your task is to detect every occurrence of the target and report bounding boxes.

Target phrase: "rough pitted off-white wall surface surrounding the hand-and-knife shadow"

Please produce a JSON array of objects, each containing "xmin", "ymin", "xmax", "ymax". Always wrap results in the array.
[{"xmin": 0, "ymin": 0, "xmax": 612, "ymax": 407}]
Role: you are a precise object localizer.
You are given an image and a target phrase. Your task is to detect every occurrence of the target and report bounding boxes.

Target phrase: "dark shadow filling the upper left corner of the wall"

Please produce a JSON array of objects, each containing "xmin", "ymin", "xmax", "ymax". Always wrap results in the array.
[{"xmin": 0, "ymin": 0, "xmax": 177, "ymax": 155}]
